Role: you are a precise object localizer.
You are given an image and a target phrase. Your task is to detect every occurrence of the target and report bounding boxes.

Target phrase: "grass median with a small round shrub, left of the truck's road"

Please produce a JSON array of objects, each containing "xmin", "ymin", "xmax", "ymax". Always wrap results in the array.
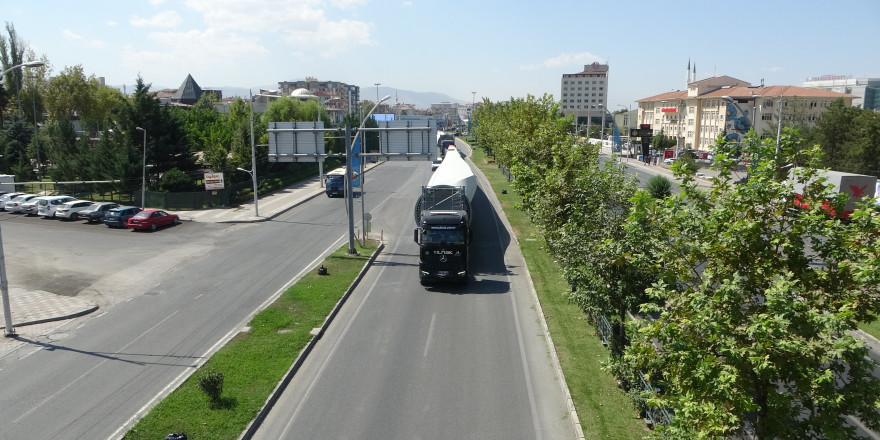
[{"xmin": 125, "ymin": 241, "xmax": 377, "ymax": 440}]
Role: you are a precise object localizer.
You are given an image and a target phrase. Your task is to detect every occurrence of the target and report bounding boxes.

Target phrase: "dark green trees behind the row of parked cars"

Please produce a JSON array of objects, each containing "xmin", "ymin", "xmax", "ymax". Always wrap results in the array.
[{"xmin": 0, "ymin": 23, "xmax": 378, "ymax": 198}]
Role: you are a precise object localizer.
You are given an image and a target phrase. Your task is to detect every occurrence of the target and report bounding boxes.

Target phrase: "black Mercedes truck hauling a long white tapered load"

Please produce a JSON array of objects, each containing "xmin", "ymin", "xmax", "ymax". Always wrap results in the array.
[{"xmin": 413, "ymin": 147, "xmax": 477, "ymax": 286}]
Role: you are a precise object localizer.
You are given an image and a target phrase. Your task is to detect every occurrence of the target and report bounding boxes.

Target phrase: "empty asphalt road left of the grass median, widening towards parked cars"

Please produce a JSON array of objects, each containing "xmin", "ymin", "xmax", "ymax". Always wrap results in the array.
[{"xmin": 0, "ymin": 197, "xmax": 368, "ymax": 439}]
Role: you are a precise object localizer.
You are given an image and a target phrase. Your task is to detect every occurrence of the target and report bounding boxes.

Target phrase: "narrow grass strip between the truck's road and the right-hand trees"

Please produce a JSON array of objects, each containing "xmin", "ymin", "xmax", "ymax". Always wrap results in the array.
[{"xmin": 472, "ymin": 148, "xmax": 646, "ymax": 439}]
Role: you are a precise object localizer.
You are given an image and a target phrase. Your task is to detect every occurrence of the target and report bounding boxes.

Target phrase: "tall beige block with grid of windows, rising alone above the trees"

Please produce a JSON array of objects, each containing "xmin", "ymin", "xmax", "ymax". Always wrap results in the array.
[{"xmin": 560, "ymin": 63, "xmax": 612, "ymax": 130}]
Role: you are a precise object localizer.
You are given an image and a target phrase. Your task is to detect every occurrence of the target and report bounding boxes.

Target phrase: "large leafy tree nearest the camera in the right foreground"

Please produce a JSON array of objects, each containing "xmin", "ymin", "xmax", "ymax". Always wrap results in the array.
[{"xmin": 626, "ymin": 132, "xmax": 880, "ymax": 439}]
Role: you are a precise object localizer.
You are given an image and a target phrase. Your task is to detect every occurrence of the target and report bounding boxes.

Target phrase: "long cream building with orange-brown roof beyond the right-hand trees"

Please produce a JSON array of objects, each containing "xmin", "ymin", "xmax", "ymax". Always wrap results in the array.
[{"xmin": 636, "ymin": 74, "xmax": 855, "ymax": 151}]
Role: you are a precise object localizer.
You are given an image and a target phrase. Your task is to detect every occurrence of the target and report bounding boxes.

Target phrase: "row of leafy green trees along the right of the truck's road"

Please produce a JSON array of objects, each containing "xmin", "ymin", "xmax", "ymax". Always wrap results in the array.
[{"xmin": 475, "ymin": 95, "xmax": 880, "ymax": 439}]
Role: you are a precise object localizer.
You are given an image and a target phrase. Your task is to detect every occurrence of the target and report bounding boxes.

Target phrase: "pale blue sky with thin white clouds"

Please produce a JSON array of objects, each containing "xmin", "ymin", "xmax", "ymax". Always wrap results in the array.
[{"xmin": 0, "ymin": 0, "xmax": 880, "ymax": 109}]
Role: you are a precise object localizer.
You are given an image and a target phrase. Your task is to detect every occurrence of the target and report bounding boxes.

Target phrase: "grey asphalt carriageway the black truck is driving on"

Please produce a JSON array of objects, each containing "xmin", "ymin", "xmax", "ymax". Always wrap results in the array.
[{"xmin": 255, "ymin": 149, "xmax": 575, "ymax": 439}]
